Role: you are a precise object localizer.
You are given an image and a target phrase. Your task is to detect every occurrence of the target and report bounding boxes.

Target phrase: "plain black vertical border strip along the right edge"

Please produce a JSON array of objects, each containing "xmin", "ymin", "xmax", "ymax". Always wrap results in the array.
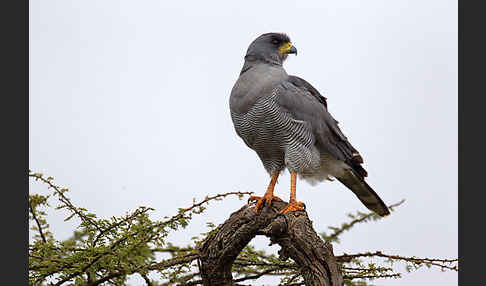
[{"xmin": 460, "ymin": 1, "xmax": 486, "ymax": 285}]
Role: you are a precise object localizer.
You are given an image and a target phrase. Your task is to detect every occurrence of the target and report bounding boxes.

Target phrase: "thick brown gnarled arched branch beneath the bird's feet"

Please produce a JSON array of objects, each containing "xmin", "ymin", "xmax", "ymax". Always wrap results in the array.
[{"xmin": 199, "ymin": 201, "xmax": 343, "ymax": 286}]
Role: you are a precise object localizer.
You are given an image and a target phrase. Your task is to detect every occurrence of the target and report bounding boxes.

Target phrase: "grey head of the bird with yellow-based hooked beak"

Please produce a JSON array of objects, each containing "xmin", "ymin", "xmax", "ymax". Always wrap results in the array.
[{"xmin": 245, "ymin": 33, "xmax": 297, "ymax": 65}]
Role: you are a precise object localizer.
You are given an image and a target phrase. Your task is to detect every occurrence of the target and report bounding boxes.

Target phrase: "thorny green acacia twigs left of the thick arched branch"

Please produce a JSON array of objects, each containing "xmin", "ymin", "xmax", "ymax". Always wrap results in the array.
[{"xmin": 29, "ymin": 171, "xmax": 251, "ymax": 285}]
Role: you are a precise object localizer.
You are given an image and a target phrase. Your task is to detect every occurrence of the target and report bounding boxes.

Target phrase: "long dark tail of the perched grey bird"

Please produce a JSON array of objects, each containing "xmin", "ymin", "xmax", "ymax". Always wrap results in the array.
[{"xmin": 336, "ymin": 170, "xmax": 390, "ymax": 216}]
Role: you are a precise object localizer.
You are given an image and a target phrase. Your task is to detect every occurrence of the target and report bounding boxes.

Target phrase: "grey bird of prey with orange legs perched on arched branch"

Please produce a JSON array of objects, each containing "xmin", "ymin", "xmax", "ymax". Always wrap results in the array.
[{"xmin": 229, "ymin": 32, "xmax": 390, "ymax": 216}]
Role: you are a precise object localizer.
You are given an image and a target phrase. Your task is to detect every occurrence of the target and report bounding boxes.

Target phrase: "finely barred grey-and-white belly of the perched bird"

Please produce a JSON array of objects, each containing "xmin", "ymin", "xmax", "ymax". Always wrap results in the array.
[{"xmin": 231, "ymin": 87, "xmax": 320, "ymax": 177}]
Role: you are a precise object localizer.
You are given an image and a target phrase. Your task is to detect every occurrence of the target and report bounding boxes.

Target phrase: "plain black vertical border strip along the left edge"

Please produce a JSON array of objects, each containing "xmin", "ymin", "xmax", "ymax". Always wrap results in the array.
[{"xmin": 0, "ymin": 0, "xmax": 29, "ymax": 285}]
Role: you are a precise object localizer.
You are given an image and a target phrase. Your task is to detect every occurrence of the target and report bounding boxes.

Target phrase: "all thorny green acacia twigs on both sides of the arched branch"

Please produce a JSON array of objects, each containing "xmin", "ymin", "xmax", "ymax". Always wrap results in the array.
[{"xmin": 29, "ymin": 171, "xmax": 458, "ymax": 286}]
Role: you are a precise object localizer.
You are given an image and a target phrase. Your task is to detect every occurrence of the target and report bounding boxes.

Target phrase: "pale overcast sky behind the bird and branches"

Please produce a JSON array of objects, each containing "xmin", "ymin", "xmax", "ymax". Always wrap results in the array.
[{"xmin": 29, "ymin": 0, "xmax": 458, "ymax": 286}]
